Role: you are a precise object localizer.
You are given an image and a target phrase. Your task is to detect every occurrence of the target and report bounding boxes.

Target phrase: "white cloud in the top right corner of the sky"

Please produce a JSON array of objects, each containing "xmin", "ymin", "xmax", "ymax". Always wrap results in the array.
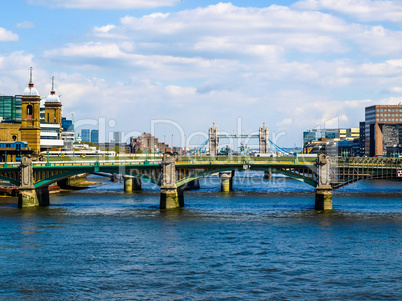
[{"xmin": 294, "ymin": 0, "xmax": 402, "ymax": 22}]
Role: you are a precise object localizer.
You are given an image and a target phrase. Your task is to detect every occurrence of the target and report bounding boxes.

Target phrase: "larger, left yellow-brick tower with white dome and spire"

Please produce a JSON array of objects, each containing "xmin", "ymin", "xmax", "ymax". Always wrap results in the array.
[{"xmin": 20, "ymin": 67, "xmax": 40, "ymax": 155}]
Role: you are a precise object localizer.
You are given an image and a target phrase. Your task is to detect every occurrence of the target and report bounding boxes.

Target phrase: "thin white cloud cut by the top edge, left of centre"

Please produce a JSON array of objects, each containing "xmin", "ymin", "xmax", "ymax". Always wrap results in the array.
[{"xmin": 28, "ymin": 0, "xmax": 179, "ymax": 9}]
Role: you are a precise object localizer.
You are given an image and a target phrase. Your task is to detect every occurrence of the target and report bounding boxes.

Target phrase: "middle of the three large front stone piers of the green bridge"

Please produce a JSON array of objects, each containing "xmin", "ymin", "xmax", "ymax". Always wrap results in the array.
[{"xmin": 160, "ymin": 153, "xmax": 184, "ymax": 209}]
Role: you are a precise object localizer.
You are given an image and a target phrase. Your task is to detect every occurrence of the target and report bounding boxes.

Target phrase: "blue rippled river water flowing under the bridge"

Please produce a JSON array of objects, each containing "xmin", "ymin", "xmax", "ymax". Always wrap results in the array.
[{"xmin": 0, "ymin": 174, "xmax": 402, "ymax": 300}]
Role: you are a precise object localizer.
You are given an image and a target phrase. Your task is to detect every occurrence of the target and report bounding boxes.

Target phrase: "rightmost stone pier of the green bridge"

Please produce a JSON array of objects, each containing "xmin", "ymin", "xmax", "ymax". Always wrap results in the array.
[{"xmin": 315, "ymin": 154, "xmax": 332, "ymax": 210}]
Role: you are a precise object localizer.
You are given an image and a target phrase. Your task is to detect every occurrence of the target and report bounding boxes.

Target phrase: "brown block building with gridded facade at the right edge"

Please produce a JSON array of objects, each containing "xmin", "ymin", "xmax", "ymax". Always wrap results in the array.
[{"xmin": 365, "ymin": 105, "xmax": 402, "ymax": 157}]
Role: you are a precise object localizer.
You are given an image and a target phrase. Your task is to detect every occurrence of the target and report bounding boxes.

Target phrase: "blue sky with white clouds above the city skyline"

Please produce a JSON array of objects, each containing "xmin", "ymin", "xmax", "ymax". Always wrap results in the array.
[{"xmin": 0, "ymin": 0, "xmax": 402, "ymax": 146}]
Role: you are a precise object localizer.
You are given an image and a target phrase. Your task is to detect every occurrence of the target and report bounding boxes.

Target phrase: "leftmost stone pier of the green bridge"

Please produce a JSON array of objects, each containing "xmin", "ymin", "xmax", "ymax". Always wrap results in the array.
[{"xmin": 18, "ymin": 156, "xmax": 39, "ymax": 208}]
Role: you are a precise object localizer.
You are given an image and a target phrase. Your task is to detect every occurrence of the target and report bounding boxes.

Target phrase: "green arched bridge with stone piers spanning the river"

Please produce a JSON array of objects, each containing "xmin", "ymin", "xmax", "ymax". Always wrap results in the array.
[{"xmin": 0, "ymin": 153, "xmax": 402, "ymax": 210}]
